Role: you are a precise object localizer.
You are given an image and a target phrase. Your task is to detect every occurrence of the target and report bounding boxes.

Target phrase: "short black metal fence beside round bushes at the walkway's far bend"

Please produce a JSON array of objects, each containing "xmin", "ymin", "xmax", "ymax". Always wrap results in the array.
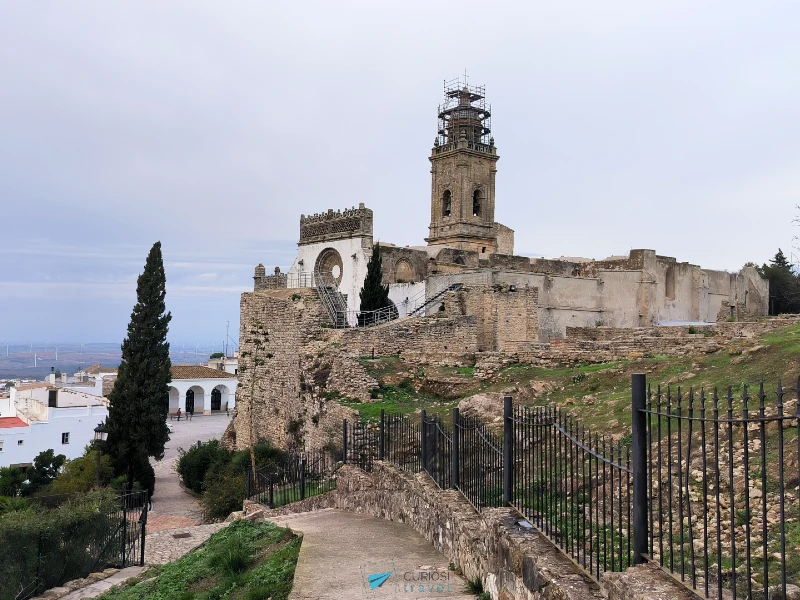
[{"xmin": 247, "ymin": 452, "xmax": 338, "ymax": 508}]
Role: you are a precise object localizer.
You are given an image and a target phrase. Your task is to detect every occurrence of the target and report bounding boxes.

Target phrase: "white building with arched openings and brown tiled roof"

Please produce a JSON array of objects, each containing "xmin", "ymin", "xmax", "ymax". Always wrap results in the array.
[{"xmin": 169, "ymin": 365, "xmax": 234, "ymax": 415}]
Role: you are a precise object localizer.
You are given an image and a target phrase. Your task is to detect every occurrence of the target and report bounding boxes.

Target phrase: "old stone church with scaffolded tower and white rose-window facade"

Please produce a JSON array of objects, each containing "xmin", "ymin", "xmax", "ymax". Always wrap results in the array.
[{"xmin": 254, "ymin": 80, "xmax": 769, "ymax": 344}]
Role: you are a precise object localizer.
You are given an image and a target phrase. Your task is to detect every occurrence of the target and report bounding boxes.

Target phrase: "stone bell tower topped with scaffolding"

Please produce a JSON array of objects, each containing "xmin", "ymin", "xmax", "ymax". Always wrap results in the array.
[{"xmin": 425, "ymin": 79, "xmax": 502, "ymax": 254}]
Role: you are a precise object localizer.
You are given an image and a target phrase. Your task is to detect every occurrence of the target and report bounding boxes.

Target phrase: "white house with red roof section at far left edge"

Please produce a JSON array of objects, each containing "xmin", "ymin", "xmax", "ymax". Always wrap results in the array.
[{"xmin": 0, "ymin": 383, "xmax": 108, "ymax": 467}]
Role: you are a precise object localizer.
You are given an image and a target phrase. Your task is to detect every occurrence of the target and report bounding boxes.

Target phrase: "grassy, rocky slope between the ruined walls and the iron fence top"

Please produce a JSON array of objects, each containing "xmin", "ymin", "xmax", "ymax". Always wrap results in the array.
[{"xmin": 346, "ymin": 324, "xmax": 800, "ymax": 436}]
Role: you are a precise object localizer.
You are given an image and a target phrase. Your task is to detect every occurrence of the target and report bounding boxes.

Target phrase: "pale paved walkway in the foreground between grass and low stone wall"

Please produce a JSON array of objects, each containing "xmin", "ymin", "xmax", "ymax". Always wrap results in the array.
[{"xmin": 270, "ymin": 508, "xmax": 468, "ymax": 600}]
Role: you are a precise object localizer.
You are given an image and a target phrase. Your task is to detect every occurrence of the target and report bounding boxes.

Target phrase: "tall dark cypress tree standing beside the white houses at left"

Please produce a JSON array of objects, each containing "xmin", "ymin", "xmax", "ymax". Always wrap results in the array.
[{"xmin": 105, "ymin": 242, "xmax": 172, "ymax": 493}]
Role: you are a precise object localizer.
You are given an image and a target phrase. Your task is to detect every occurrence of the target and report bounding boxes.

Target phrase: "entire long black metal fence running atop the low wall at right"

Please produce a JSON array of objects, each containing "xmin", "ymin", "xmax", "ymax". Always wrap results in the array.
[{"xmin": 336, "ymin": 375, "xmax": 800, "ymax": 600}]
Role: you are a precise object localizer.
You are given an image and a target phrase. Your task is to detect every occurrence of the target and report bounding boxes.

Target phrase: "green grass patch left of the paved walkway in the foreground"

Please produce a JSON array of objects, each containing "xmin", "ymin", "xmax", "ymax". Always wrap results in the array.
[{"xmin": 99, "ymin": 521, "xmax": 301, "ymax": 600}]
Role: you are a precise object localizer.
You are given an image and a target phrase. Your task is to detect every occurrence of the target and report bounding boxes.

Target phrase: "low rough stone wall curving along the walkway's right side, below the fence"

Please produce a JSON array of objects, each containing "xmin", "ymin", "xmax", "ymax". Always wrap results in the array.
[{"xmin": 244, "ymin": 462, "xmax": 694, "ymax": 600}]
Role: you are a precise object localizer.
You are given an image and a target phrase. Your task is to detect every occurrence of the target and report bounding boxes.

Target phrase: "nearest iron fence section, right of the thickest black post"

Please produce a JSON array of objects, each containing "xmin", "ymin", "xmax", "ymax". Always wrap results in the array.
[{"xmin": 634, "ymin": 381, "xmax": 800, "ymax": 599}]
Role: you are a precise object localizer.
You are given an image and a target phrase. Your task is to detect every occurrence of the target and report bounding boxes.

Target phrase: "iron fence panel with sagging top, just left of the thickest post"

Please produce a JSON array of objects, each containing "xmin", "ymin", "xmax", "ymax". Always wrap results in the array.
[{"xmin": 505, "ymin": 398, "xmax": 633, "ymax": 578}]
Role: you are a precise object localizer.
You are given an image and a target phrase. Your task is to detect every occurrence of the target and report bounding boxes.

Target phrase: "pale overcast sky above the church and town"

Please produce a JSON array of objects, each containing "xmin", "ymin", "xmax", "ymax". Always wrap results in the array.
[{"xmin": 0, "ymin": 0, "xmax": 800, "ymax": 344}]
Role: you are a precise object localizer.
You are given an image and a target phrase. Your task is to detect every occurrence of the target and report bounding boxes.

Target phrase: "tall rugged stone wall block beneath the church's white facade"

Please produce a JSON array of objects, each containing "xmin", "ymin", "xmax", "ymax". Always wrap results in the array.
[{"xmin": 231, "ymin": 289, "xmax": 354, "ymax": 450}]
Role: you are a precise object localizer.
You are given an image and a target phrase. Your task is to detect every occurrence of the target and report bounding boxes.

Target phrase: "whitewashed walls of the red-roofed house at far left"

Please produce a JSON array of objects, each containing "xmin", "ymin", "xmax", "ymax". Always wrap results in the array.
[{"xmin": 0, "ymin": 406, "xmax": 108, "ymax": 467}]
